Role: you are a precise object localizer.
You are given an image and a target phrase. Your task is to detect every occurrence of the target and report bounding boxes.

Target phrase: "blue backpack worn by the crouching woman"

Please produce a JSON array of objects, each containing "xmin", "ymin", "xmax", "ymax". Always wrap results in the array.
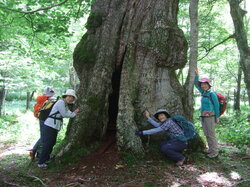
[{"xmin": 171, "ymin": 115, "xmax": 197, "ymax": 141}]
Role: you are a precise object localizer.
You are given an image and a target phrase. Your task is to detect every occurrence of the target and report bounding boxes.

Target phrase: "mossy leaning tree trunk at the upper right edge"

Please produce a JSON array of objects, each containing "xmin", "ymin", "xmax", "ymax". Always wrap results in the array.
[{"xmin": 228, "ymin": 0, "xmax": 250, "ymax": 105}]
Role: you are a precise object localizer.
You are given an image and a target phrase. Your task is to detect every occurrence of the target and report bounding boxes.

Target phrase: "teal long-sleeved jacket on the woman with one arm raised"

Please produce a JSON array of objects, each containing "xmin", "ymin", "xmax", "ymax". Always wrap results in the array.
[{"xmin": 194, "ymin": 76, "xmax": 220, "ymax": 118}]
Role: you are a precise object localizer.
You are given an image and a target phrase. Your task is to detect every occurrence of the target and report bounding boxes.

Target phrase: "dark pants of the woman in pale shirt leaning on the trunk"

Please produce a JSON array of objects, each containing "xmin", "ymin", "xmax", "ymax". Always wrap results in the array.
[{"xmin": 38, "ymin": 125, "xmax": 58, "ymax": 164}]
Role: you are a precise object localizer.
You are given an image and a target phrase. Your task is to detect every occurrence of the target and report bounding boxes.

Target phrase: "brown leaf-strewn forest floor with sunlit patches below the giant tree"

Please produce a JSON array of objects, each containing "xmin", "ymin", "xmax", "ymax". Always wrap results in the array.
[{"xmin": 0, "ymin": 137, "xmax": 250, "ymax": 187}]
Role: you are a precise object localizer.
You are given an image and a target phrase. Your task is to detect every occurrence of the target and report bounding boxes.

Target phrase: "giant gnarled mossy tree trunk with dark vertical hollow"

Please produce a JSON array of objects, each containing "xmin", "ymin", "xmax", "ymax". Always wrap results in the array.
[{"xmin": 61, "ymin": 0, "xmax": 187, "ymax": 153}]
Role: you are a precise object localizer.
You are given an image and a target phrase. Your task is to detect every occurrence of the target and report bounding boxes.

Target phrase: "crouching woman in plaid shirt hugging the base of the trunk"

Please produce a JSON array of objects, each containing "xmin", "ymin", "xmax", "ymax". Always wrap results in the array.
[{"xmin": 135, "ymin": 109, "xmax": 187, "ymax": 166}]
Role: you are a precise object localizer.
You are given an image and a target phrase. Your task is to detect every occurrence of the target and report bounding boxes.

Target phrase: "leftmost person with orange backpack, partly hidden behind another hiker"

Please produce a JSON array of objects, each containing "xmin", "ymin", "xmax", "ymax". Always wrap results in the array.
[{"xmin": 29, "ymin": 86, "xmax": 55, "ymax": 160}]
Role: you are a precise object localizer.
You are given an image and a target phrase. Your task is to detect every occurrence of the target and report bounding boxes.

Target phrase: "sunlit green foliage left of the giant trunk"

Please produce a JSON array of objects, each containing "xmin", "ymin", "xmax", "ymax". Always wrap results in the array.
[{"xmin": 0, "ymin": 0, "xmax": 90, "ymax": 111}]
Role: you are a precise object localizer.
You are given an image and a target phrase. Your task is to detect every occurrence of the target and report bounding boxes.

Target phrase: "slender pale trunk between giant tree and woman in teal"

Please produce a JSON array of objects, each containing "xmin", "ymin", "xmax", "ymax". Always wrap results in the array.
[{"xmin": 184, "ymin": 0, "xmax": 199, "ymax": 121}]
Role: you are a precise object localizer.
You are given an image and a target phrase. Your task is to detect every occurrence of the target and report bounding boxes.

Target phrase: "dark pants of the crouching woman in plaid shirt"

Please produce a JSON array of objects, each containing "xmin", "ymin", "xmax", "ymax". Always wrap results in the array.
[{"xmin": 160, "ymin": 140, "xmax": 187, "ymax": 161}]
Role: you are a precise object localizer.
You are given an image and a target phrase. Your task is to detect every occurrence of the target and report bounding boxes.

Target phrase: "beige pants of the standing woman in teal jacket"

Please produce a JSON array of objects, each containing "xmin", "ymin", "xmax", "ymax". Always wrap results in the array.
[{"xmin": 201, "ymin": 116, "xmax": 219, "ymax": 155}]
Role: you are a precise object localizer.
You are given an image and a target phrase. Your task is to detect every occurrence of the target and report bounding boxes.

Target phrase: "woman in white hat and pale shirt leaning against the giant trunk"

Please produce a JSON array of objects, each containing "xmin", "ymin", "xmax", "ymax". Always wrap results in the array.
[{"xmin": 38, "ymin": 89, "xmax": 80, "ymax": 168}]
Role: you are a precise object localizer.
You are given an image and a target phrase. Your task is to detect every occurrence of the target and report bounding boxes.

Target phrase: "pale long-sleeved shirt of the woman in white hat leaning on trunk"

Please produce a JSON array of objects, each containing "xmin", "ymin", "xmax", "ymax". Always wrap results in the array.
[{"xmin": 44, "ymin": 100, "xmax": 76, "ymax": 131}]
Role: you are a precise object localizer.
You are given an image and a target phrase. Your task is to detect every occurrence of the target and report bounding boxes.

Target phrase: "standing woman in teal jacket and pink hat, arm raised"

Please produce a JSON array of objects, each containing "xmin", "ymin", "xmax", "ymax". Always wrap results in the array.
[{"xmin": 195, "ymin": 69, "xmax": 220, "ymax": 158}]
